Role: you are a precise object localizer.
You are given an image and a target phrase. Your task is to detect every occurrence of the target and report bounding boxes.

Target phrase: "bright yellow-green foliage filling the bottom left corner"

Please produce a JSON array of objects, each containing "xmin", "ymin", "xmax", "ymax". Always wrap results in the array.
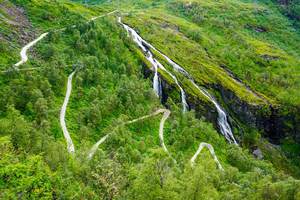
[{"xmin": 0, "ymin": 137, "xmax": 55, "ymax": 199}]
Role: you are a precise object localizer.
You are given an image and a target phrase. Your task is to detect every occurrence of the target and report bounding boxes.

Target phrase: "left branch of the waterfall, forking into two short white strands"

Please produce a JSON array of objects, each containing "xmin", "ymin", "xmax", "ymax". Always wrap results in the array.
[{"xmin": 118, "ymin": 17, "xmax": 188, "ymax": 112}]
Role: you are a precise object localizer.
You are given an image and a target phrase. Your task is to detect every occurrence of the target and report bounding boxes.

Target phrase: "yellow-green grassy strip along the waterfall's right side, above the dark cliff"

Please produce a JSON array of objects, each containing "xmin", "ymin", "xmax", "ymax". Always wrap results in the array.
[{"xmin": 125, "ymin": 10, "xmax": 263, "ymax": 104}]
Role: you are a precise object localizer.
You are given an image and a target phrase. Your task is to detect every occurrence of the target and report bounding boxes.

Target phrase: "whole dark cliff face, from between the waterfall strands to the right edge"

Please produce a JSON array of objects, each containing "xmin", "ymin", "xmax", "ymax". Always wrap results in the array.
[{"xmin": 143, "ymin": 62, "xmax": 300, "ymax": 144}]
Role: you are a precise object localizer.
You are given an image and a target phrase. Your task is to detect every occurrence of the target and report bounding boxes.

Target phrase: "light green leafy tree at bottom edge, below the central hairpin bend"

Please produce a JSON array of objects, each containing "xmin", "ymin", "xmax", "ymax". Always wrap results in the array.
[{"xmin": 126, "ymin": 149, "xmax": 180, "ymax": 200}]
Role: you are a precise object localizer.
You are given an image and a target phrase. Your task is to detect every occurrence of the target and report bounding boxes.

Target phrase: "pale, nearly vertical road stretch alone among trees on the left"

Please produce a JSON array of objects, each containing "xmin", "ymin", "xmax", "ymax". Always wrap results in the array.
[{"xmin": 60, "ymin": 71, "xmax": 76, "ymax": 153}]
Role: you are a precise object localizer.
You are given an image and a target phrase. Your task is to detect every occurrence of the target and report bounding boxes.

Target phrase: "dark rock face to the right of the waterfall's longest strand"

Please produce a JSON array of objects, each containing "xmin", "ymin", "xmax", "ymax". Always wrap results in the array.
[{"xmin": 216, "ymin": 85, "xmax": 300, "ymax": 144}]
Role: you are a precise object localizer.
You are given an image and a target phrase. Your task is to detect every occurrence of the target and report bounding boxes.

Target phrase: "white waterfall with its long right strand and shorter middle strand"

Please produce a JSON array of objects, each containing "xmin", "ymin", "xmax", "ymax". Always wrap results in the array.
[{"xmin": 119, "ymin": 17, "xmax": 237, "ymax": 144}]
